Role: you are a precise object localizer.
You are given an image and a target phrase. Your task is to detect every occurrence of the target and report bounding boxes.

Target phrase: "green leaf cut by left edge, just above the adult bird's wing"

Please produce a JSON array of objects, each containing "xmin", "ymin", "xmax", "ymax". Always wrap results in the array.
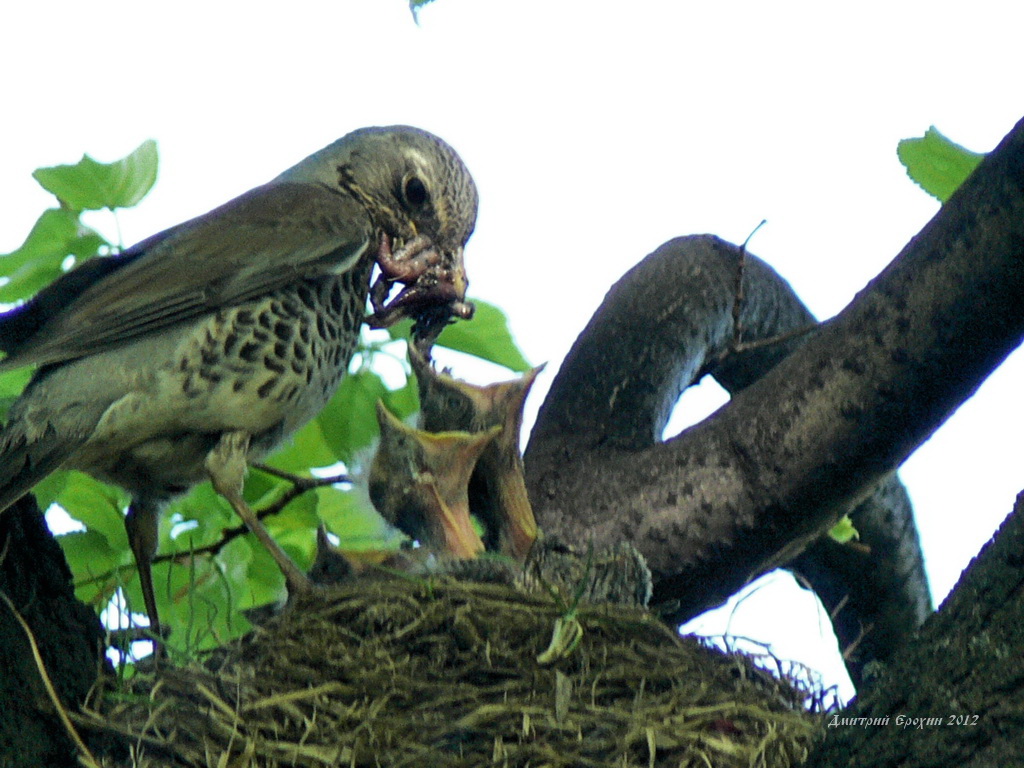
[{"xmin": 0, "ymin": 208, "xmax": 106, "ymax": 302}]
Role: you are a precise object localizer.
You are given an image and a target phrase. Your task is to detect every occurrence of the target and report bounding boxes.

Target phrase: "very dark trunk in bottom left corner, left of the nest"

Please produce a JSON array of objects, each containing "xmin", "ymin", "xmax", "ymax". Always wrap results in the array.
[{"xmin": 0, "ymin": 495, "xmax": 103, "ymax": 768}]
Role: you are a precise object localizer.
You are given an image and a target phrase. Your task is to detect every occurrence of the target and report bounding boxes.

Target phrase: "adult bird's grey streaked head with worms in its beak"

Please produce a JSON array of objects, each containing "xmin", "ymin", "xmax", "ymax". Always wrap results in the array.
[{"xmin": 282, "ymin": 126, "xmax": 477, "ymax": 344}]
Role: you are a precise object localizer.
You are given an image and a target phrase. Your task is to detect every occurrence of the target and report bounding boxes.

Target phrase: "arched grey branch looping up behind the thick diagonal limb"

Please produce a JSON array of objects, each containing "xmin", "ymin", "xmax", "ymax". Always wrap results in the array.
[{"xmin": 525, "ymin": 236, "xmax": 815, "ymax": 450}]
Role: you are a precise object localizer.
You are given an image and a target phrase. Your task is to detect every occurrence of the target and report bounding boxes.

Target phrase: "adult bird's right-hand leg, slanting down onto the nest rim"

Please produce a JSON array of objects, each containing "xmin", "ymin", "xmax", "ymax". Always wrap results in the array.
[{"xmin": 206, "ymin": 430, "xmax": 310, "ymax": 595}]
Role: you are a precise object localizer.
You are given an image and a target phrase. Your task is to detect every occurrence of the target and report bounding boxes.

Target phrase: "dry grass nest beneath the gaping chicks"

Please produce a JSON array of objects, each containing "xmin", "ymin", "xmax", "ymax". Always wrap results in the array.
[{"xmin": 77, "ymin": 577, "xmax": 820, "ymax": 768}]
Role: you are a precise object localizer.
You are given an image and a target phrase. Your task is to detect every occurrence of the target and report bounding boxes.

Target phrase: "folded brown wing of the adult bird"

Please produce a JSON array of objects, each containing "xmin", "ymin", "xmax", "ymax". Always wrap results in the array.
[{"xmin": 0, "ymin": 181, "xmax": 373, "ymax": 371}]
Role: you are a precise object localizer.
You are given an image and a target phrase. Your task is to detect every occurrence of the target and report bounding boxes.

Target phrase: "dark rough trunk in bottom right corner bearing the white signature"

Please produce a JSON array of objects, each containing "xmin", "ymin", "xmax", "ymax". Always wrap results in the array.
[{"xmin": 809, "ymin": 494, "xmax": 1024, "ymax": 768}]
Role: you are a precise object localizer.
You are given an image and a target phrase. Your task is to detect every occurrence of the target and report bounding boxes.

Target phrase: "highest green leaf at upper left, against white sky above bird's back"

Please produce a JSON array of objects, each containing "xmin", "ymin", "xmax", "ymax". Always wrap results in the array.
[{"xmin": 32, "ymin": 139, "xmax": 158, "ymax": 211}]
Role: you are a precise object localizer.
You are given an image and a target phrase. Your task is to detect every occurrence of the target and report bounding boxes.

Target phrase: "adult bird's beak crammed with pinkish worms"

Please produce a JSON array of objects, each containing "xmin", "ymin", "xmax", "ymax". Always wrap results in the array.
[{"xmin": 368, "ymin": 234, "xmax": 473, "ymax": 328}]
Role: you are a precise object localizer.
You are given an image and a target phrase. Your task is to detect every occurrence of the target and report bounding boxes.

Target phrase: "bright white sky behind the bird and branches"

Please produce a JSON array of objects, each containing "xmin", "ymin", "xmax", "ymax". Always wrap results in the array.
[{"xmin": 0, "ymin": 0, "xmax": 1024, "ymax": 696}]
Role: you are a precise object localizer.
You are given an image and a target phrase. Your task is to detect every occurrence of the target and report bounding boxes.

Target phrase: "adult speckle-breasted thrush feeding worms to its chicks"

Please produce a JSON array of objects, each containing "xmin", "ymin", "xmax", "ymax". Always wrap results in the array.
[{"xmin": 0, "ymin": 126, "xmax": 477, "ymax": 633}]
